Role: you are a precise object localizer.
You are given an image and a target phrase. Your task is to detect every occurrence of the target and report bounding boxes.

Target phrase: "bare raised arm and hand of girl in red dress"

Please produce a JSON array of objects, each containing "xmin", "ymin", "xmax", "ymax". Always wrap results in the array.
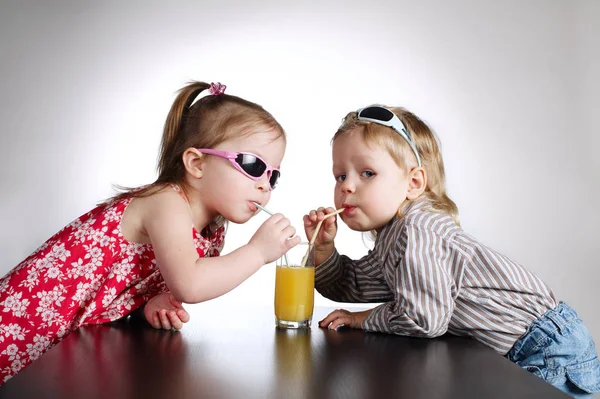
[{"xmin": 142, "ymin": 191, "xmax": 300, "ymax": 303}]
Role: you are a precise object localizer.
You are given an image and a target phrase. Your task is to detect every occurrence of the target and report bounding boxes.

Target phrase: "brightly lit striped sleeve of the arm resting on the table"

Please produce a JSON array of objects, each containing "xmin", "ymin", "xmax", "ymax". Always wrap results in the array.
[{"xmin": 362, "ymin": 225, "xmax": 454, "ymax": 338}]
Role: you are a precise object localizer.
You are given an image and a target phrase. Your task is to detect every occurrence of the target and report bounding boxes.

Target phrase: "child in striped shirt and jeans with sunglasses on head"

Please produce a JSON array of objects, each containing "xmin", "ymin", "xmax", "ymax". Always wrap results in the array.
[{"xmin": 304, "ymin": 106, "xmax": 600, "ymax": 396}]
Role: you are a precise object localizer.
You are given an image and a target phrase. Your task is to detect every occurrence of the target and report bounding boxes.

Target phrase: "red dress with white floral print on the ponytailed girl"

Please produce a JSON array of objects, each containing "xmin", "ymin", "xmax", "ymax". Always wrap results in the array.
[{"xmin": 0, "ymin": 187, "xmax": 225, "ymax": 385}]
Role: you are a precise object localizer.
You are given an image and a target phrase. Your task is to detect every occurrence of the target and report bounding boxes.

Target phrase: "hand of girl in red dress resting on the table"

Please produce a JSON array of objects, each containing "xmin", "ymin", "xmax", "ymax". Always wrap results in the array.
[{"xmin": 144, "ymin": 292, "xmax": 190, "ymax": 330}]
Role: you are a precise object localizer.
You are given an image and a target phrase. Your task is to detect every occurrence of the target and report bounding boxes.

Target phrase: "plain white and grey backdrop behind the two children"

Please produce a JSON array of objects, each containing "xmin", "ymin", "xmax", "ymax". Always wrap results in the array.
[{"xmin": 0, "ymin": 0, "xmax": 600, "ymax": 342}]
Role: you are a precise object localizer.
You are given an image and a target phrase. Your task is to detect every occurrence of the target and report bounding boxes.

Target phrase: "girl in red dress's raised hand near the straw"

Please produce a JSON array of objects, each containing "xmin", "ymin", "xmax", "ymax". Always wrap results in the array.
[{"xmin": 248, "ymin": 213, "xmax": 300, "ymax": 265}]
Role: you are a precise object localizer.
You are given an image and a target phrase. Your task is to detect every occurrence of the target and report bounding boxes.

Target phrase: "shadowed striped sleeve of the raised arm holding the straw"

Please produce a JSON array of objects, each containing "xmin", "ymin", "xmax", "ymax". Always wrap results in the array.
[{"xmin": 315, "ymin": 250, "xmax": 394, "ymax": 302}]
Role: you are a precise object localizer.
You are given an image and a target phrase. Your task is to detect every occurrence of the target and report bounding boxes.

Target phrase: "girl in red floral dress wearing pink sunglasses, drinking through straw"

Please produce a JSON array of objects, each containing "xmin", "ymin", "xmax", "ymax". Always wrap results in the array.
[{"xmin": 0, "ymin": 82, "xmax": 300, "ymax": 385}]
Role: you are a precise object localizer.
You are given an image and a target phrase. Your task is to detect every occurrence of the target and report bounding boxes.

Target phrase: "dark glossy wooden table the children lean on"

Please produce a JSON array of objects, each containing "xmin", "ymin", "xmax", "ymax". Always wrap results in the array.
[{"xmin": 0, "ymin": 301, "xmax": 568, "ymax": 399}]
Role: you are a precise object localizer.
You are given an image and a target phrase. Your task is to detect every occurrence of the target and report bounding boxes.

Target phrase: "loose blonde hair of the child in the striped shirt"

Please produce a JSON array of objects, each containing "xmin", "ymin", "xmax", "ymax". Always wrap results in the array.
[{"xmin": 332, "ymin": 107, "xmax": 459, "ymax": 228}]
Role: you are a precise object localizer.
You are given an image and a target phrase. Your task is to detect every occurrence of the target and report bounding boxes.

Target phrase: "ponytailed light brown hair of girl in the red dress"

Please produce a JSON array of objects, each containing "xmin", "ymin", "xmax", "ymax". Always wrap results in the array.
[{"xmin": 107, "ymin": 81, "xmax": 285, "ymax": 225}]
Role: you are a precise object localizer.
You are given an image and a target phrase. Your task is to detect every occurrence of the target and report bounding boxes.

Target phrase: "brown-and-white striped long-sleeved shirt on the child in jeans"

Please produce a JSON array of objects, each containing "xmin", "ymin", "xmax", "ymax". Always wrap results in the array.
[{"xmin": 315, "ymin": 197, "xmax": 557, "ymax": 354}]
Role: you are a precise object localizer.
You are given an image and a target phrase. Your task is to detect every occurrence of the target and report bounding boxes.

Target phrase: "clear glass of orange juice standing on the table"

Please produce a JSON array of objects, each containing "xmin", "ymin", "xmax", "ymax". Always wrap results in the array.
[{"xmin": 275, "ymin": 242, "xmax": 315, "ymax": 328}]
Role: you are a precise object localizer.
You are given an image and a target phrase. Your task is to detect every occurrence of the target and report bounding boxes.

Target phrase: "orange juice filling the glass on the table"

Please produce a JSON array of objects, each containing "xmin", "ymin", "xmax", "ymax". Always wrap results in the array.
[{"xmin": 275, "ymin": 266, "xmax": 315, "ymax": 324}]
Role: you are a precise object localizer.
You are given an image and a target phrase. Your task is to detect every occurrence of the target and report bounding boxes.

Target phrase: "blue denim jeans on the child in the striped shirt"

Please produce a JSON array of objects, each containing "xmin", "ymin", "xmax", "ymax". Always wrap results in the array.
[{"xmin": 506, "ymin": 302, "xmax": 600, "ymax": 398}]
